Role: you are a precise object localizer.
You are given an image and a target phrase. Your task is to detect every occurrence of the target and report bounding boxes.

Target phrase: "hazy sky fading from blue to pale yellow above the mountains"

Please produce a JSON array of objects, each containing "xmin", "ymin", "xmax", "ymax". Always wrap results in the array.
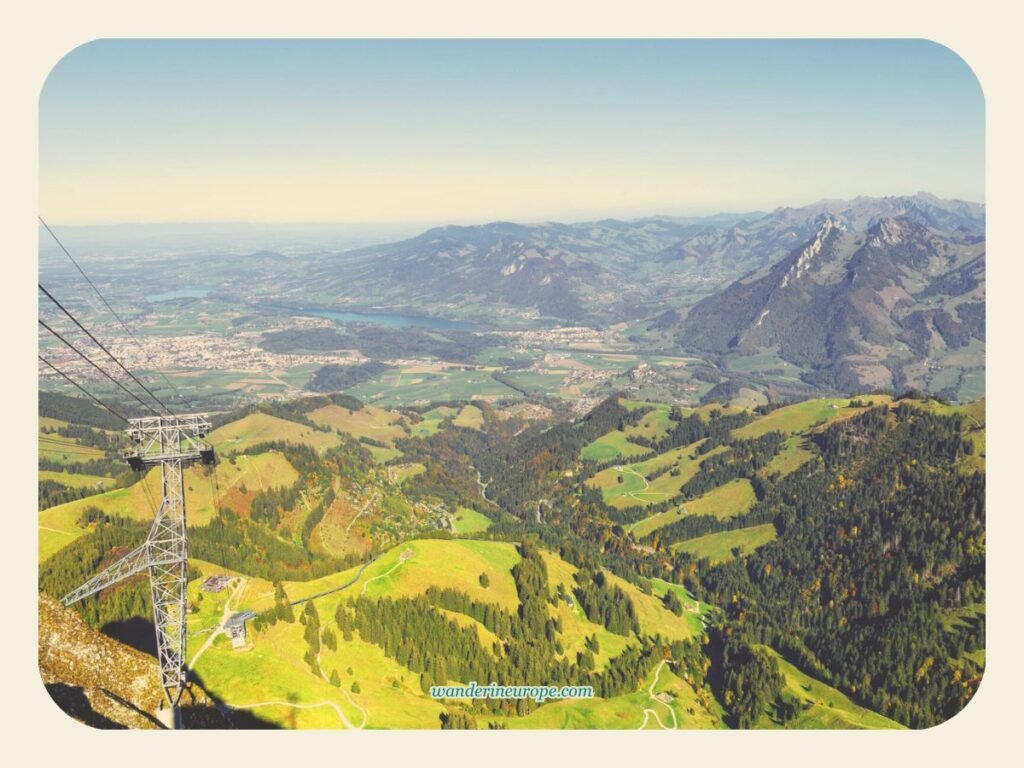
[{"xmin": 40, "ymin": 40, "xmax": 984, "ymax": 224}]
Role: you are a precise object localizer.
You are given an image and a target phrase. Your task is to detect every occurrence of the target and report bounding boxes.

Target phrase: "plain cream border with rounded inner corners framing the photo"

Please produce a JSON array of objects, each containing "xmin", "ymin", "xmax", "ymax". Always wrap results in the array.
[{"xmin": 0, "ymin": 0, "xmax": 1024, "ymax": 766}]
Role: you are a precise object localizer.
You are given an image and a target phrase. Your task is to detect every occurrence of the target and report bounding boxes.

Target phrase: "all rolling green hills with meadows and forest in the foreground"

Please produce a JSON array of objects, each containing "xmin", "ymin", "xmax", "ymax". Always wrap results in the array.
[{"xmin": 39, "ymin": 397, "xmax": 985, "ymax": 730}]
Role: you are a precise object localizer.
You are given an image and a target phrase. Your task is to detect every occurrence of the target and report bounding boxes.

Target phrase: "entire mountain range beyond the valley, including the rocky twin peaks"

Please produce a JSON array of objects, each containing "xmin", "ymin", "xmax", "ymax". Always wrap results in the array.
[{"xmin": 266, "ymin": 193, "xmax": 985, "ymax": 399}]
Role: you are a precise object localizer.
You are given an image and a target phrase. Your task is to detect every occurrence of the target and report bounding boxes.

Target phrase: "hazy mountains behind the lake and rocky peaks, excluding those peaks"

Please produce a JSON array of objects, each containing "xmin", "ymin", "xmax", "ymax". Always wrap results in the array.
[{"xmin": 285, "ymin": 194, "xmax": 984, "ymax": 324}]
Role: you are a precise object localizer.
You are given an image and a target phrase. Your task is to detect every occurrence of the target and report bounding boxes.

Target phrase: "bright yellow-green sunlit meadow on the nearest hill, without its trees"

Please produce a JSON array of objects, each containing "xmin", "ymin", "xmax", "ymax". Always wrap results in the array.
[{"xmin": 188, "ymin": 540, "xmax": 722, "ymax": 728}]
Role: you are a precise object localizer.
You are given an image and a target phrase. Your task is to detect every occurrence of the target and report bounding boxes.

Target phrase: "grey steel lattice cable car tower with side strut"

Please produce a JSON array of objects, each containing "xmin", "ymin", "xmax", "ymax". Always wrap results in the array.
[{"xmin": 62, "ymin": 414, "xmax": 215, "ymax": 726}]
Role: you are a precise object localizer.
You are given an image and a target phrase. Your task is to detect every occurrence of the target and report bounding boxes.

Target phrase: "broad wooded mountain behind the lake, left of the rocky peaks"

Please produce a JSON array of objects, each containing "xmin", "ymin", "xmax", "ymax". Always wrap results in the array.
[{"xmin": 294, "ymin": 216, "xmax": 753, "ymax": 323}]
